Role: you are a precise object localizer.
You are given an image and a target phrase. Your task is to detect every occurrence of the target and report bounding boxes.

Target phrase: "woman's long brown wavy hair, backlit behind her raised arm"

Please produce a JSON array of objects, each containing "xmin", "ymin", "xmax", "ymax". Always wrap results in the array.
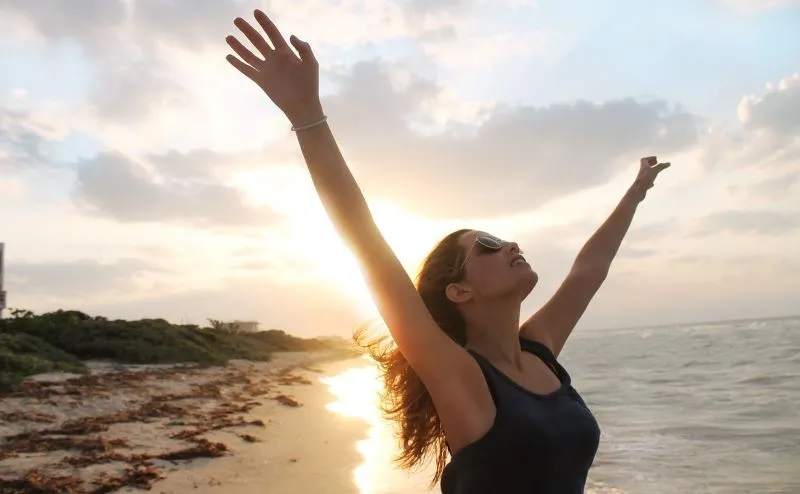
[{"xmin": 354, "ymin": 229, "xmax": 470, "ymax": 486}]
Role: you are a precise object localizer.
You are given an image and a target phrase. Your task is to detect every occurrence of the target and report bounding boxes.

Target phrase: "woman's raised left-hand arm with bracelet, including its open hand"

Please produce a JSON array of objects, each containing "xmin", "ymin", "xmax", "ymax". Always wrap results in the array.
[{"xmin": 227, "ymin": 11, "xmax": 479, "ymax": 384}]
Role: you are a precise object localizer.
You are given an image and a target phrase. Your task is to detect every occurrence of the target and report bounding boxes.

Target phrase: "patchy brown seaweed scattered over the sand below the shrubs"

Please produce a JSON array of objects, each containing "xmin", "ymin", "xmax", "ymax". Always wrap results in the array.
[{"xmin": 0, "ymin": 358, "xmax": 315, "ymax": 494}]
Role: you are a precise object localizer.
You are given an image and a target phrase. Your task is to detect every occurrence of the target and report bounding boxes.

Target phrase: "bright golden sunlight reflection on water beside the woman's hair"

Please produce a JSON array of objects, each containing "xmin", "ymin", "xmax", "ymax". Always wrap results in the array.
[{"xmin": 322, "ymin": 359, "xmax": 438, "ymax": 494}]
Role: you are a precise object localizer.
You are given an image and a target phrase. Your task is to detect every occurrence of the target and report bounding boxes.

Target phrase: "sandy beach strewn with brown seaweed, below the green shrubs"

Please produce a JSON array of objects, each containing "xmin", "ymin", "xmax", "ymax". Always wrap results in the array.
[{"xmin": 0, "ymin": 351, "xmax": 365, "ymax": 494}]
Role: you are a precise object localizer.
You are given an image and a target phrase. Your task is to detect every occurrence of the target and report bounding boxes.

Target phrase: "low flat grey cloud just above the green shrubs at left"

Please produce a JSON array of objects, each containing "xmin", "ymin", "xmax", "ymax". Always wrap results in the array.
[{"xmin": 8, "ymin": 259, "xmax": 163, "ymax": 297}]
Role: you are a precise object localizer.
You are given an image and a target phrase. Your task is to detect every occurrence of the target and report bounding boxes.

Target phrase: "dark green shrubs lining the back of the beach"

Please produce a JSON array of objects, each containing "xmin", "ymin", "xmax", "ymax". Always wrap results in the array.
[{"xmin": 0, "ymin": 310, "xmax": 354, "ymax": 391}]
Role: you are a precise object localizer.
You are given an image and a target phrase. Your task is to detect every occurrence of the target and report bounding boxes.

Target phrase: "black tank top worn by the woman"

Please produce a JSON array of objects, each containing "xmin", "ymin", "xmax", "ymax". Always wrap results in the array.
[{"xmin": 441, "ymin": 338, "xmax": 600, "ymax": 494}]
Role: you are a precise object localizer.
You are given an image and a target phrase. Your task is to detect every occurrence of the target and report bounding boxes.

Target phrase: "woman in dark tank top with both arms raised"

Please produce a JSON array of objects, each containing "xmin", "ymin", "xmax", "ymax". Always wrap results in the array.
[{"xmin": 227, "ymin": 10, "xmax": 669, "ymax": 494}]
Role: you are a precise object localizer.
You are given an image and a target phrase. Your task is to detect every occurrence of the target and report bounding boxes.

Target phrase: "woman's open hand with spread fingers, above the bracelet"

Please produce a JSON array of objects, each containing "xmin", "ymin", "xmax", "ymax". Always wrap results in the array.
[{"xmin": 225, "ymin": 10, "xmax": 323, "ymax": 126}]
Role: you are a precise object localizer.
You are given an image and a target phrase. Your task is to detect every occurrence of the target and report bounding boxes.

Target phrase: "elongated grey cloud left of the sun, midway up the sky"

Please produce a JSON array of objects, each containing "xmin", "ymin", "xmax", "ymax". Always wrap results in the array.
[{"xmin": 74, "ymin": 153, "xmax": 282, "ymax": 227}]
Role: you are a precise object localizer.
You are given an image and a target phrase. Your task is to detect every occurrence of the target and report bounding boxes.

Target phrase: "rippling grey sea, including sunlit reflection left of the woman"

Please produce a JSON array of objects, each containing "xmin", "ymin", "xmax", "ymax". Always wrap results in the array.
[{"xmin": 324, "ymin": 317, "xmax": 800, "ymax": 494}]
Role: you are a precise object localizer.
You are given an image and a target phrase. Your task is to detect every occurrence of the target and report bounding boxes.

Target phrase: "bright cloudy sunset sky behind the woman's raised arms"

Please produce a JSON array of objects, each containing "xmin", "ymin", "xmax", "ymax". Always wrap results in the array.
[{"xmin": 0, "ymin": 0, "xmax": 800, "ymax": 336}]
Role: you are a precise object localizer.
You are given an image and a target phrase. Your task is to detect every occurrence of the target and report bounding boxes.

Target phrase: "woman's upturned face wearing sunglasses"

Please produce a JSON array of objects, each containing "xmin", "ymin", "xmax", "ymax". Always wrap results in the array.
[{"xmin": 459, "ymin": 230, "xmax": 539, "ymax": 302}]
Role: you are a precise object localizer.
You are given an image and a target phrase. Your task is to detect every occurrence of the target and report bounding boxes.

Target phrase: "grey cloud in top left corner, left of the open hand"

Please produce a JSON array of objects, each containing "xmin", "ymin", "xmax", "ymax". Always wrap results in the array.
[{"xmin": 0, "ymin": 0, "xmax": 198, "ymax": 122}]
